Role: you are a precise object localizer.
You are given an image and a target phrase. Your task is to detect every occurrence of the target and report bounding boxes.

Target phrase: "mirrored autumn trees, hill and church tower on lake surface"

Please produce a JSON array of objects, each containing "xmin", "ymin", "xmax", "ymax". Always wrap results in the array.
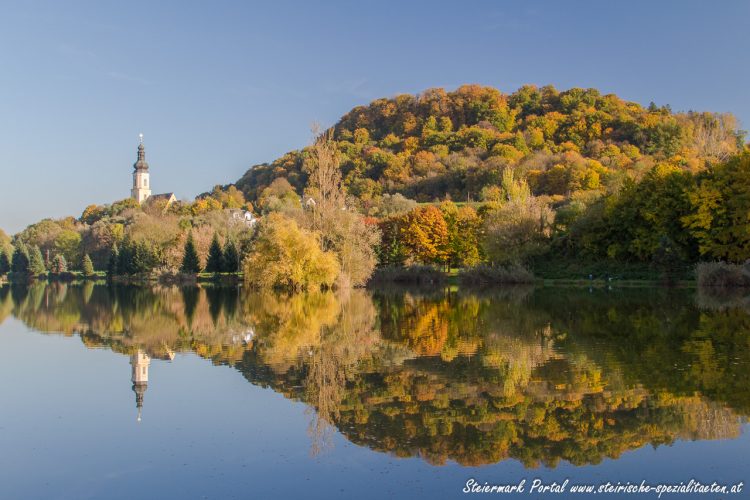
[{"xmin": 0, "ymin": 283, "xmax": 750, "ymax": 467}]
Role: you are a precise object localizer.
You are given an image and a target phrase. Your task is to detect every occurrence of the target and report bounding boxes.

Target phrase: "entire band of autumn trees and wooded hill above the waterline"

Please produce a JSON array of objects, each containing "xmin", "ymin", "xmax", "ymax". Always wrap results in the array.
[{"xmin": 0, "ymin": 85, "xmax": 750, "ymax": 289}]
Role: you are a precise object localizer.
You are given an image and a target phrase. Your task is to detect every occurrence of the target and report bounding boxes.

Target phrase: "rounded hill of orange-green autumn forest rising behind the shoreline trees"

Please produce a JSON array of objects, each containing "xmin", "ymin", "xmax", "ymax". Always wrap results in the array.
[{"xmin": 236, "ymin": 85, "xmax": 744, "ymax": 207}]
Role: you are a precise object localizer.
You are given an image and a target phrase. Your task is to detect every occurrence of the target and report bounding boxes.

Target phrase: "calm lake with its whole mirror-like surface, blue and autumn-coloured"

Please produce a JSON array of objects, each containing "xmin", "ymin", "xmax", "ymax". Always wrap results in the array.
[{"xmin": 0, "ymin": 283, "xmax": 750, "ymax": 499}]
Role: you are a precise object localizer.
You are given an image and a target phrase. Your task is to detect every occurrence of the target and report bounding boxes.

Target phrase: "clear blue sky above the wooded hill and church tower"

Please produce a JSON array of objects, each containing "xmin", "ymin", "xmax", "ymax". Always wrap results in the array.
[{"xmin": 0, "ymin": 0, "xmax": 750, "ymax": 233}]
